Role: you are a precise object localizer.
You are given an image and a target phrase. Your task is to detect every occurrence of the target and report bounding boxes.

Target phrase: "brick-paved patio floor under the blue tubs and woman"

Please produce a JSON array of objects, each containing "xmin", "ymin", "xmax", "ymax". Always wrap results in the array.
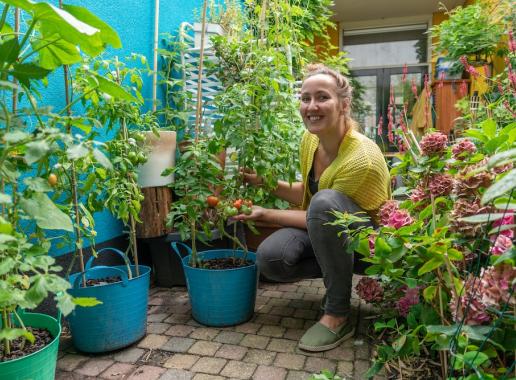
[{"xmin": 56, "ymin": 276, "xmax": 388, "ymax": 380}]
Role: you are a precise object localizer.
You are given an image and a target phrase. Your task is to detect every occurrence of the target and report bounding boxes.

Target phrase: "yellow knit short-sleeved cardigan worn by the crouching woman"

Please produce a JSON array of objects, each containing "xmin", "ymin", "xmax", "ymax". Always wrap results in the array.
[{"xmin": 300, "ymin": 129, "xmax": 391, "ymax": 215}]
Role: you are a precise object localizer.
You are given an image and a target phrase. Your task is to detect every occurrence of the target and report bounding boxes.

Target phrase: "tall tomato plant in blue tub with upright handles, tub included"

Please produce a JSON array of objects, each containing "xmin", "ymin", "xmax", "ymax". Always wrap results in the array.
[{"xmin": 56, "ymin": 56, "xmax": 156, "ymax": 352}]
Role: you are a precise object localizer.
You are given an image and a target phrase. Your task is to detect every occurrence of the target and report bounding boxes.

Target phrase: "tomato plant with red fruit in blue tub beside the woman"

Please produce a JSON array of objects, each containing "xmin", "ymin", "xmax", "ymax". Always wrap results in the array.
[{"xmin": 169, "ymin": 135, "xmax": 258, "ymax": 326}]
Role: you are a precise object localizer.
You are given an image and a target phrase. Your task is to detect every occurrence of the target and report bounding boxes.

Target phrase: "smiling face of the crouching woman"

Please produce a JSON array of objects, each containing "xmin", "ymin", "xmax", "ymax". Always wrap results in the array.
[{"xmin": 299, "ymin": 74, "xmax": 347, "ymax": 134}]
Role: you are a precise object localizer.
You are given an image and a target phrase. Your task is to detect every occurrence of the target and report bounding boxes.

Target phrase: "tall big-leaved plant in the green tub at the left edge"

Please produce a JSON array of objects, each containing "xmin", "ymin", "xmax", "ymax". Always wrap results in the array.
[{"xmin": 0, "ymin": 0, "xmax": 119, "ymax": 379}]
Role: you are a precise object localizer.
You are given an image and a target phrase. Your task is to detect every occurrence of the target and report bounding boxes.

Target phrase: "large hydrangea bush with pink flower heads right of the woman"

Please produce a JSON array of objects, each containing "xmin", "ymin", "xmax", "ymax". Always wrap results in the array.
[{"xmin": 336, "ymin": 29, "xmax": 516, "ymax": 379}]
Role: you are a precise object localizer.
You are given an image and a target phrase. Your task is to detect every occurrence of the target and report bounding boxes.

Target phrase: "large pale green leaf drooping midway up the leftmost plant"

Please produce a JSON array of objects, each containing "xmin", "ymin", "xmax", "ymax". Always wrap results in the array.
[{"xmin": 20, "ymin": 193, "xmax": 73, "ymax": 232}]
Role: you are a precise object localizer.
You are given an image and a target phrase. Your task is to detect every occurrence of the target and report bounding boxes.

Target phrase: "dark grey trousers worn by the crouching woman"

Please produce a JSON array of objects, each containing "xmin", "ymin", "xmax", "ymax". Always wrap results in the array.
[{"xmin": 257, "ymin": 190, "xmax": 370, "ymax": 316}]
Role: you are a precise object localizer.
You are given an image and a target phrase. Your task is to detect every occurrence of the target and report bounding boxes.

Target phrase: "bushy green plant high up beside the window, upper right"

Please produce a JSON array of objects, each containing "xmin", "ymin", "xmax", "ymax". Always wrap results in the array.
[{"xmin": 430, "ymin": 1, "xmax": 504, "ymax": 78}]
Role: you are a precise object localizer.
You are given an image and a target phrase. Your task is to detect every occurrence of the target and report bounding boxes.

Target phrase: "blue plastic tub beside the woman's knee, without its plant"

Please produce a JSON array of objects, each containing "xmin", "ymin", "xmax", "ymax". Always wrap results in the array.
[{"xmin": 171, "ymin": 242, "xmax": 258, "ymax": 327}]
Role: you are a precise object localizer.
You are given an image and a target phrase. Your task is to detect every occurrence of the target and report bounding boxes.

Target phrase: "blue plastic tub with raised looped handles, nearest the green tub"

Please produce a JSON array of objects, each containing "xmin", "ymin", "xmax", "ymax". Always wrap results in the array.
[{"xmin": 67, "ymin": 248, "xmax": 151, "ymax": 353}]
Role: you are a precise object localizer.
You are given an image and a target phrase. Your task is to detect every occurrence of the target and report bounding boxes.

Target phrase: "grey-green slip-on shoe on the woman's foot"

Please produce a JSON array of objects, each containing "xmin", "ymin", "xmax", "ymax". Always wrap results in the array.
[{"xmin": 298, "ymin": 320, "xmax": 355, "ymax": 352}]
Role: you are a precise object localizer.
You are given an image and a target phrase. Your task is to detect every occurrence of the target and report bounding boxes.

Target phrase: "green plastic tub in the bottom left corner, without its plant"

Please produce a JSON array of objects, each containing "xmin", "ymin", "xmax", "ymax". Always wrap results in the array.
[{"xmin": 0, "ymin": 310, "xmax": 61, "ymax": 380}]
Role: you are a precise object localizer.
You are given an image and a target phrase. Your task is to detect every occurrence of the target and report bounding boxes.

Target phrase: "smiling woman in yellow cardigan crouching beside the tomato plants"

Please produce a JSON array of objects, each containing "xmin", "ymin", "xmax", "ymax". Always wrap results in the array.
[{"xmin": 235, "ymin": 65, "xmax": 390, "ymax": 352}]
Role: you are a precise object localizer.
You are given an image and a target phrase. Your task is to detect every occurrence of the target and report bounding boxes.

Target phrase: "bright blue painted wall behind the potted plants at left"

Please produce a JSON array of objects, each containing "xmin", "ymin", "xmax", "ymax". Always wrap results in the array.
[{"xmin": 44, "ymin": 0, "xmax": 206, "ymax": 255}]
